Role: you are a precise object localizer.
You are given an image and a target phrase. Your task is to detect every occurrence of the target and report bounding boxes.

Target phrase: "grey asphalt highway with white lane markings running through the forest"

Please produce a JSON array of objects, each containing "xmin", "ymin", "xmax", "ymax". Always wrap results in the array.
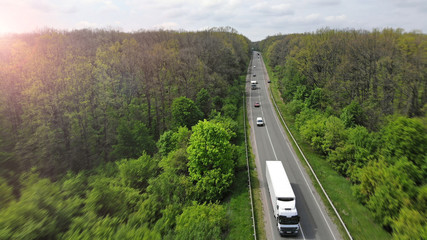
[{"xmin": 246, "ymin": 52, "xmax": 342, "ymax": 240}]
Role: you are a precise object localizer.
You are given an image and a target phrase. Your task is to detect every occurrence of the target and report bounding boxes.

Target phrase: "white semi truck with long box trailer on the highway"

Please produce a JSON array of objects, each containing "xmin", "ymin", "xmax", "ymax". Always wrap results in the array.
[{"xmin": 266, "ymin": 161, "xmax": 300, "ymax": 236}]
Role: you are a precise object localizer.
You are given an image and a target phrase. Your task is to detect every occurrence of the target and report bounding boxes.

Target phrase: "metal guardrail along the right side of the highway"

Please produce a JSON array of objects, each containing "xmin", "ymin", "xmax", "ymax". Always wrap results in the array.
[{"xmin": 262, "ymin": 55, "xmax": 353, "ymax": 240}]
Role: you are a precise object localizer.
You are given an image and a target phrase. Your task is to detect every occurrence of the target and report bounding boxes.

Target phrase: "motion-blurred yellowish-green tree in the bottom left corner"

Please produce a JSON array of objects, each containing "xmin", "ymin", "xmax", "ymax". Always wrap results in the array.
[{"xmin": 0, "ymin": 173, "xmax": 83, "ymax": 239}]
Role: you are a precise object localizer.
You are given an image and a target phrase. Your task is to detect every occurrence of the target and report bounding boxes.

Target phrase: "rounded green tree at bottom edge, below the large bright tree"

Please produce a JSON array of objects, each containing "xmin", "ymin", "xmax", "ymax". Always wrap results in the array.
[{"xmin": 175, "ymin": 204, "xmax": 227, "ymax": 239}]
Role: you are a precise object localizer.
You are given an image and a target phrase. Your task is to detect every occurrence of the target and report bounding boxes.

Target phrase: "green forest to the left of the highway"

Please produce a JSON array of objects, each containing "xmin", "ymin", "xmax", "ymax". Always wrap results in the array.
[{"xmin": 0, "ymin": 27, "xmax": 253, "ymax": 240}]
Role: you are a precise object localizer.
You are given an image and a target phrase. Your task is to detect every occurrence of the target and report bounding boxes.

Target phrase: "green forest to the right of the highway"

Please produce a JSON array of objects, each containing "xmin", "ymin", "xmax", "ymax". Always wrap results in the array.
[{"xmin": 257, "ymin": 29, "xmax": 427, "ymax": 239}]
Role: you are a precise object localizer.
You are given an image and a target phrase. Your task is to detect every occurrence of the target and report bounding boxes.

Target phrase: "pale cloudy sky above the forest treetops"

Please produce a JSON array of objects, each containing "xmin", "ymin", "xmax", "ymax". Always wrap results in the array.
[{"xmin": 0, "ymin": 0, "xmax": 427, "ymax": 41}]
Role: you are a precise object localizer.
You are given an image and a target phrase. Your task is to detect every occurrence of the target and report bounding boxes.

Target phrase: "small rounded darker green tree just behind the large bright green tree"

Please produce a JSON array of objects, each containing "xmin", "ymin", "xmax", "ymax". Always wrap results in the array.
[{"xmin": 172, "ymin": 97, "xmax": 203, "ymax": 128}]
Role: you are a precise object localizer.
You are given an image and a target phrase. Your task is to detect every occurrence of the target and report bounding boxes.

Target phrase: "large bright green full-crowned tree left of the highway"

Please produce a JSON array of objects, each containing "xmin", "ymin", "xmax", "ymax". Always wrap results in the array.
[{"xmin": 187, "ymin": 120, "xmax": 234, "ymax": 201}]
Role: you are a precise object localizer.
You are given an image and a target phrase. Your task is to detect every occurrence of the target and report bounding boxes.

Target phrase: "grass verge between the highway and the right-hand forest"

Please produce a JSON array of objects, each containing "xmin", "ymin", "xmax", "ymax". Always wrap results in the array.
[{"xmin": 266, "ymin": 65, "xmax": 391, "ymax": 239}]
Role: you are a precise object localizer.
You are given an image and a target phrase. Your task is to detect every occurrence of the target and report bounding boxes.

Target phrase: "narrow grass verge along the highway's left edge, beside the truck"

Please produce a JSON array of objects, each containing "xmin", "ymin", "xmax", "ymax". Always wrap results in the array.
[{"xmin": 224, "ymin": 75, "xmax": 266, "ymax": 240}]
